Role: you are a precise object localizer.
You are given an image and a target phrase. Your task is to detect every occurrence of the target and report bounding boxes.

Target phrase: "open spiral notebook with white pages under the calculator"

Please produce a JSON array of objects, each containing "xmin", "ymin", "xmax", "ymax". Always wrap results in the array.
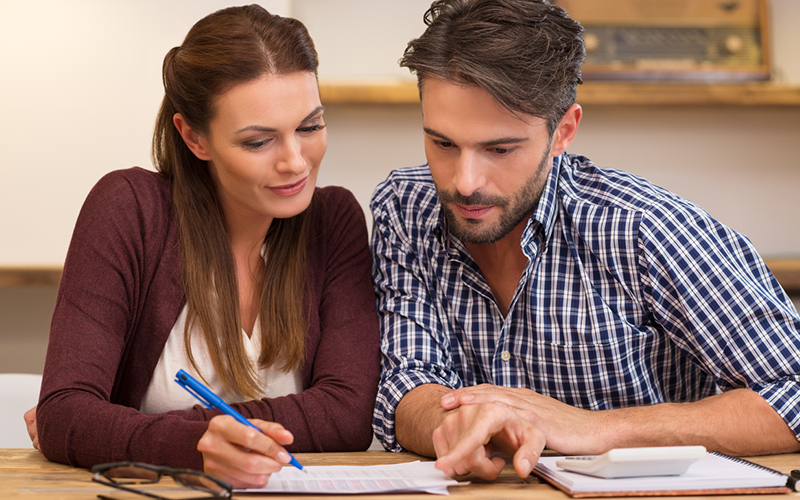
[{"xmin": 533, "ymin": 451, "xmax": 790, "ymax": 498}]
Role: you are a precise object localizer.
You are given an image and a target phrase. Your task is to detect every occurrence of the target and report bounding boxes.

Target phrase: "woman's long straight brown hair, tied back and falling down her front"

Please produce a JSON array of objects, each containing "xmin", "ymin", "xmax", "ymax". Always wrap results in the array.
[{"xmin": 152, "ymin": 5, "xmax": 317, "ymax": 399}]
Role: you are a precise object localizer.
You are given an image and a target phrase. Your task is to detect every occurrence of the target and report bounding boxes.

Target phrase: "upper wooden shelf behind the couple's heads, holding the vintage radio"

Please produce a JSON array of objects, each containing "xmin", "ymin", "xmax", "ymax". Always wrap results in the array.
[{"xmin": 319, "ymin": 81, "xmax": 800, "ymax": 106}]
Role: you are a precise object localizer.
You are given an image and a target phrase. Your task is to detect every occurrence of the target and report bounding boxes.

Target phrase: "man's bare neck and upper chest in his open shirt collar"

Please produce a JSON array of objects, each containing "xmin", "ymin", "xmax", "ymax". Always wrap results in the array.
[{"xmin": 464, "ymin": 217, "xmax": 529, "ymax": 316}]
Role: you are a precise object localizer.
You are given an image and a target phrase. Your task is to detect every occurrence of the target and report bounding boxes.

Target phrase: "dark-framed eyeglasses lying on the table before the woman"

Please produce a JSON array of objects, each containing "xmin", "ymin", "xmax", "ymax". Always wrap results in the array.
[{"xmin": 92, "ymin": 462, "xmax": 233, "ymax": 500}]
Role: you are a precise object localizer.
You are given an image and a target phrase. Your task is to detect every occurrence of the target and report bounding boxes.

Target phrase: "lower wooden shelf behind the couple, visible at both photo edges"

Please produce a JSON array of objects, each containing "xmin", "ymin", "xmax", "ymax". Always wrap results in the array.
[{"xmin": 0, "ymin": 258, "xmax": 800, "ymax": 296}]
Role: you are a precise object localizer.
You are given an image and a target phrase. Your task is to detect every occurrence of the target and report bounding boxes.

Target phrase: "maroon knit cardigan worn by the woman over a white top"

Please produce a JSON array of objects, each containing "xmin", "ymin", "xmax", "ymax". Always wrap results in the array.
[{"xmin": 36, "ymin": 168, "xmax": 379, "ymax": 470}]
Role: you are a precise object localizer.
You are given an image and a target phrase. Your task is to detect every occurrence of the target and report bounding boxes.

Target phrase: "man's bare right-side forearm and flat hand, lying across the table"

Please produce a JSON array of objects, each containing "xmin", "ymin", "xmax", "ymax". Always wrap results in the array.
[{"xmin": 441, "ymin": 385, "xmax": 800, "ymax": 456}]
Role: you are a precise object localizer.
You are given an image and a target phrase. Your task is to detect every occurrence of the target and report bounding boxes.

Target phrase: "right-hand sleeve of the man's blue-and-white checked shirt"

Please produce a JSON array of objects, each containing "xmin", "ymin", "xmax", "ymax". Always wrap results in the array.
[{"xmin": 641, "ymin": 200, "xmax": 800, "ymax": 440}]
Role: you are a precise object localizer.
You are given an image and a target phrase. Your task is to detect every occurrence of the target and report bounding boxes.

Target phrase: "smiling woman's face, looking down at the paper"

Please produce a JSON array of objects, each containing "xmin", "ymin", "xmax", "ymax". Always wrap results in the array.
[{"xmin": 195, "ymin": 72, "xmax": 328, "ymax": 230}]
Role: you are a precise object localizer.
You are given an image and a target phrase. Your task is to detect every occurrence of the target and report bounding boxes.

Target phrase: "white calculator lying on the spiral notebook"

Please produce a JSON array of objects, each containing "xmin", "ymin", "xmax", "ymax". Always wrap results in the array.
[{"xmin": 556, "ymin": 446, "xmax": 706, "ymax": 479}]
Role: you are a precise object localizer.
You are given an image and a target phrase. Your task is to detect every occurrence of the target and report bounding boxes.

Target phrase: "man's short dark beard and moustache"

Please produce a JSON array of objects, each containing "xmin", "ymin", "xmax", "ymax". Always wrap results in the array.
[{"xmin": 436, "ymin": 147, "xmax": 552, "ymax": 245}]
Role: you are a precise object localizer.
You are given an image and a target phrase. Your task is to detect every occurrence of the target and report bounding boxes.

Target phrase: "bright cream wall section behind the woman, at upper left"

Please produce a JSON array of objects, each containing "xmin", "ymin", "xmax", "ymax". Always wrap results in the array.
[{"xmin": 0, "ymin": 0, "xmax": 290, "ymax": 265}]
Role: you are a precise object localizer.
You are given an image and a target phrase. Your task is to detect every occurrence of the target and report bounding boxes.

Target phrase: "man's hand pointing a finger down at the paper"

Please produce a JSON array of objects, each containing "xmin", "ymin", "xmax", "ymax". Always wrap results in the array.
[{"xmin": 433, "ymin": 403, "xmax": 545, "ymax": 480}]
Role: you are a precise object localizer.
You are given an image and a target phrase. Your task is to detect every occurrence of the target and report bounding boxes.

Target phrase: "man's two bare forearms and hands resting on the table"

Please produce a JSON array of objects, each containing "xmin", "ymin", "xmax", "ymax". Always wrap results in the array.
[{"xmin": 406, "ymin": 384, "xmax": 800, "ymax": 479}]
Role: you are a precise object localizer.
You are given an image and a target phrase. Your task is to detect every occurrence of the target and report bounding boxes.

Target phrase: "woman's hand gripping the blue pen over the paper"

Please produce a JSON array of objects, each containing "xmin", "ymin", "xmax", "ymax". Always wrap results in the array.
[{"xmin": 197, "ymin": 415, "xmax": 294, "ymax": 488}]
